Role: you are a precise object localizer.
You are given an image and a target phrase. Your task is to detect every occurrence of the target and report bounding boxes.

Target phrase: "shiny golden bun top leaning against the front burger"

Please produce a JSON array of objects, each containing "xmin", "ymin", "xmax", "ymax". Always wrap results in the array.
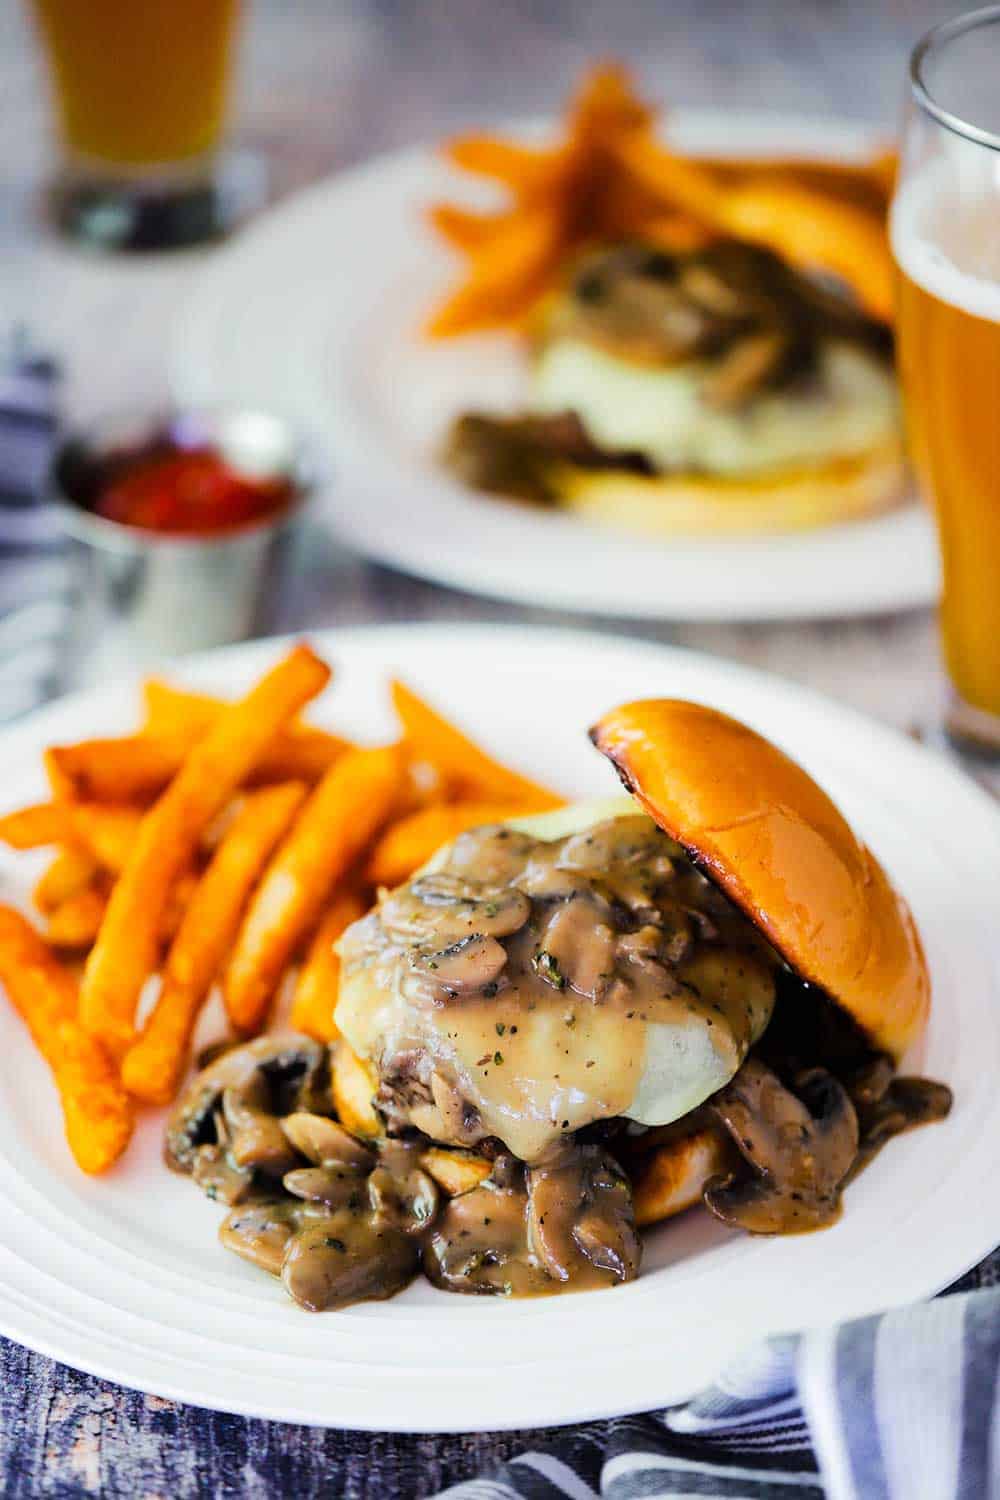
[{"xmin": 591, "ymin": 699, "xmax": 930, "ymax": 1061}]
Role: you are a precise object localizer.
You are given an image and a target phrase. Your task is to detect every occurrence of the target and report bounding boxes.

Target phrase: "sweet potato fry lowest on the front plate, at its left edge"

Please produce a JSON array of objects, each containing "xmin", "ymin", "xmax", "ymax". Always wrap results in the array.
[{"xmin": 0, "ymin": 906, "xmax": 132, "ymax": 1172}]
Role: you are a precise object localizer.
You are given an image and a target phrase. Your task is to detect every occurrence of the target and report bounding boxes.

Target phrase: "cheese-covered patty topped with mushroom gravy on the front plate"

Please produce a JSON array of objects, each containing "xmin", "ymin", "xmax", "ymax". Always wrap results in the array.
[{"xmin": 336, "ymin": 815, "xmax": 780, "ymax": 1163}]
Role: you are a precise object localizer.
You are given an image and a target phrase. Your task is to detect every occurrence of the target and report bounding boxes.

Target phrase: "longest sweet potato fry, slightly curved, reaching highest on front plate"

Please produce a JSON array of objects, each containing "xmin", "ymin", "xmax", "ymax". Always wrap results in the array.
[{"xmin": 79, "ymin": 647, "xmax": 330, "ymax": 1056}]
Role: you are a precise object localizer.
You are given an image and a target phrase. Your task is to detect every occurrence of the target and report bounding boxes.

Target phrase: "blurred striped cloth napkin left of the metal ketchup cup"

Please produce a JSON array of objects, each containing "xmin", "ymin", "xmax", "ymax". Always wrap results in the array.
[{"xmin": 0, "ymin": 333, "xmax": 73, "ymax": 722}]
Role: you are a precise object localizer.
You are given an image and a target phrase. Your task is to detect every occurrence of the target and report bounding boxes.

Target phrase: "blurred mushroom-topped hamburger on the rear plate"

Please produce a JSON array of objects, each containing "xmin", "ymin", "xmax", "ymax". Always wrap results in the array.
[{"xmin": 444, "ymin": 240, "xmax": 904, "ymax": 536}]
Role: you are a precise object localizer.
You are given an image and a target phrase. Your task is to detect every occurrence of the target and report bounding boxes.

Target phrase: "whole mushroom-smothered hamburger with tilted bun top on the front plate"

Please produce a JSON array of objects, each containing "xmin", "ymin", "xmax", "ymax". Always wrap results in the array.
[{"xmin": 166, "ymin": 699, "xmax": 951, "ymax": 1310}]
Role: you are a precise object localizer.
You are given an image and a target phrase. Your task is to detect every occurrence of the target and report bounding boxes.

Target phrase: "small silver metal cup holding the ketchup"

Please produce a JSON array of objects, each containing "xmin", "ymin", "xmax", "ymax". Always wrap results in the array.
[{"xmin": 51, "ymin": 410, "xmax": 312, "ymax": 681}]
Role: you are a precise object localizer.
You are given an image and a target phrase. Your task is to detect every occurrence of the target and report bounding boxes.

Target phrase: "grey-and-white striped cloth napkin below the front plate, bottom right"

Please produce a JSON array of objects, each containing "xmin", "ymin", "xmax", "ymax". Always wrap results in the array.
[{"xmin": 438, "ymin": 1251, "xmax": 1000, "ymax": 1500}]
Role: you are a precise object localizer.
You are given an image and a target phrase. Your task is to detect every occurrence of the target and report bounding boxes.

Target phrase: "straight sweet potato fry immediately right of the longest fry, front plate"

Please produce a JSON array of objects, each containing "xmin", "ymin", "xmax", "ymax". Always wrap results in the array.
[{"xmin": 121, "ymin": 782, "xmax": 306, "ymax": 1104}]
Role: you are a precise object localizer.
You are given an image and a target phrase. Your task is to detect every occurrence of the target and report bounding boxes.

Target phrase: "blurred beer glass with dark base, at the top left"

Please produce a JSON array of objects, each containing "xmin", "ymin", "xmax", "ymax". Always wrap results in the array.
[{"xmin": 33, "ymin": 0, "xmax": 251, "ymax": 249}]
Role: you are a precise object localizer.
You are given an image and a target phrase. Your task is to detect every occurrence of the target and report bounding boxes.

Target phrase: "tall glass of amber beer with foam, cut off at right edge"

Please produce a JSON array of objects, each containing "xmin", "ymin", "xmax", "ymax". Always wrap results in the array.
[{"xmin": 891, "ymin": 6, "xmax": 1000, "ymax": 758}]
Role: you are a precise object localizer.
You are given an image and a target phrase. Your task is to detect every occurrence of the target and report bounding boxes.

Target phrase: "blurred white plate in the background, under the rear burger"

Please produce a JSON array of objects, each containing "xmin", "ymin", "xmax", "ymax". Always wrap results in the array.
[{"xmin": 171, "ymin": 111, "xmax": 937, "ymax": 620}]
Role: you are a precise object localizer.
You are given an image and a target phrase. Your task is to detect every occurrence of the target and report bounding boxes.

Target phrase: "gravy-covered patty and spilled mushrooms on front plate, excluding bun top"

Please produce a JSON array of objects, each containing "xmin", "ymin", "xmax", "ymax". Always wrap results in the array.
[{"xmin": 166, "ymin": 816, "xmax": 951, "ymax": 1310}]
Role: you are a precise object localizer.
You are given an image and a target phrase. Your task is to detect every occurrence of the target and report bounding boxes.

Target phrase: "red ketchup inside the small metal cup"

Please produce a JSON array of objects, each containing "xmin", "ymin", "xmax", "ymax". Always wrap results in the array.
[{"xmin": 90, "ymin": 447, "xmax": 294, "ymax": 536}]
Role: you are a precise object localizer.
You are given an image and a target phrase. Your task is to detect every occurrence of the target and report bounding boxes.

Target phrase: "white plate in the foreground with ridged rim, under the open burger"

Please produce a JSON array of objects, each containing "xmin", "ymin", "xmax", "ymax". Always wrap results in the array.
[{"xmin": 0, "ymin": 626, "xmax": 1000, "ymax": 1431}]
